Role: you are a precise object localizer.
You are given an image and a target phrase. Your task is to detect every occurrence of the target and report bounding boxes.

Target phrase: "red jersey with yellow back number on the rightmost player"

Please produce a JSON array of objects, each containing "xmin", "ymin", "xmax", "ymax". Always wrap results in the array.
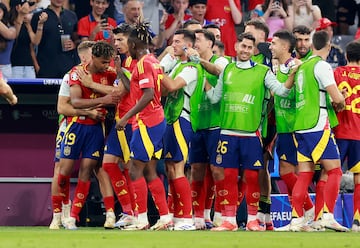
[{"xmin": 334, "ymin": 66, "xmax": 360, "ymax": 140}]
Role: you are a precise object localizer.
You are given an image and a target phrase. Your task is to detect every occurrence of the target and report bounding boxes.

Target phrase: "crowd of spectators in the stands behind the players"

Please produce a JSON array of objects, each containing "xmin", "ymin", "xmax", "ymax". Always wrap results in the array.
[{"xmin": 0, "ymin": 0, "xmax": 360, "ymax": 78}]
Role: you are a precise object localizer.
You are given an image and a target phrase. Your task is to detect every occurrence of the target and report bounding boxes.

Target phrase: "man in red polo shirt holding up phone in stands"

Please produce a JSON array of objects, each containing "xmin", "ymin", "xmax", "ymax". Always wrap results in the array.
[{"xmin": 78, "ymin": 0, "xmax": 116, "ymax": 42}]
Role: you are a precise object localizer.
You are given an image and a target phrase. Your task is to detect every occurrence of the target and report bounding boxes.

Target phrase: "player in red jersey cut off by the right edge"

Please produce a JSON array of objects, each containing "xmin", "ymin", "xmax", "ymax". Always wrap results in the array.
[{"xmin": 334, "ymin": 41, "xmax": 360, "ymax": 232}]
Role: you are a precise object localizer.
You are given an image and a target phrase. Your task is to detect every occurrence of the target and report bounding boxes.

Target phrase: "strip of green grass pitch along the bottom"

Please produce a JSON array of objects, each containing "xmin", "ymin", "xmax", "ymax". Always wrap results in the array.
[{"xmin": 0, "ymin": 227, "xmax": 360, "ymax": 248}]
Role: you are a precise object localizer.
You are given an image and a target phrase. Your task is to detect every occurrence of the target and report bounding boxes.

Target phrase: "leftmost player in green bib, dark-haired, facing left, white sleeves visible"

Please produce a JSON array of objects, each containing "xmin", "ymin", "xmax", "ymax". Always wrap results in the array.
[{"xmin": 161, "ymin": 29, "xmax": 204, "ymax": 230}]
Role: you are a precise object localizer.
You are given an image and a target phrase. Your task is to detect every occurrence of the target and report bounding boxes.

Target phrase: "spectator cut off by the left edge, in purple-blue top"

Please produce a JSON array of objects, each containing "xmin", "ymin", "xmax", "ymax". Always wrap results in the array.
[{"xmin": 0, "ymin": 0, "xmax": 30, "ymax": 78}]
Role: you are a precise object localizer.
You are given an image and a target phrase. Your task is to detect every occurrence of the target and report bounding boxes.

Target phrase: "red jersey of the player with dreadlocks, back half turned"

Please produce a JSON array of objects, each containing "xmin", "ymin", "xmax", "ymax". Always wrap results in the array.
[{"xmin": 130, "ymin": 54, "xmax": 164, "ymax": 129}]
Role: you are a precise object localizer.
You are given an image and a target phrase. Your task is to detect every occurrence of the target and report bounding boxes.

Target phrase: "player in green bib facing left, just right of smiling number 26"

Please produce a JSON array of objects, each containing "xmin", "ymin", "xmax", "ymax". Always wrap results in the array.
[{"xmin": 270, "ymin": 30, "xmax": 314, "ymax": 231}]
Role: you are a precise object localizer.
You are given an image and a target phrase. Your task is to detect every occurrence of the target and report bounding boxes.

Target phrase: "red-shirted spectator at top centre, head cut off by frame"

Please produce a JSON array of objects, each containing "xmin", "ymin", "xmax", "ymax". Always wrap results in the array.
[{"xmin": 205, "ymin": 0, "xmax": 242, "ymax": 57}]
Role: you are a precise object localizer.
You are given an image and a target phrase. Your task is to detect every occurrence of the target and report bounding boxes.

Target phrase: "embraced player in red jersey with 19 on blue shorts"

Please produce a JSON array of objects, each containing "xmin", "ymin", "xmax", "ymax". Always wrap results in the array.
[{"xmin": 58, "ymin": 41, "xmax": 119, "ymax": 230}]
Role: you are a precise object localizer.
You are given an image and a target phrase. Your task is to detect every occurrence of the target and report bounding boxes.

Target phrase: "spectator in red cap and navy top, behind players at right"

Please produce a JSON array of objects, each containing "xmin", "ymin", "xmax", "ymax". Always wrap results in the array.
[{"xmin": 316, "ymin": 18, "xmax": 346, "ymax": 69}]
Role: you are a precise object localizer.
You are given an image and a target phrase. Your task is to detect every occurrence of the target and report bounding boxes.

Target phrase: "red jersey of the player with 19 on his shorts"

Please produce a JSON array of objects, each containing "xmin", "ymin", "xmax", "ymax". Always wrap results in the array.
[{"xmin": 69, "ymin": 65, "xmax": 117, "ymax": 125}]
